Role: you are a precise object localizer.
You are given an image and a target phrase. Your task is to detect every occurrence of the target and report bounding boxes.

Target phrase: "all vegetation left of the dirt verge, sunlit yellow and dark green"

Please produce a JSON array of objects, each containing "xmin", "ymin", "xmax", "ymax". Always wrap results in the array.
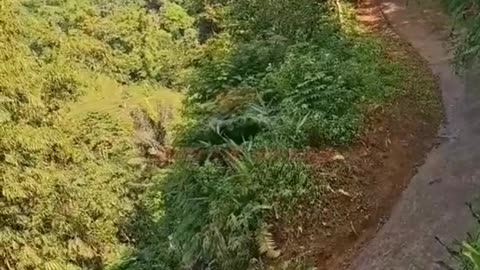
[{"xmin": 0, "ymin": 0, "xmax": 418, "ymax": 270}]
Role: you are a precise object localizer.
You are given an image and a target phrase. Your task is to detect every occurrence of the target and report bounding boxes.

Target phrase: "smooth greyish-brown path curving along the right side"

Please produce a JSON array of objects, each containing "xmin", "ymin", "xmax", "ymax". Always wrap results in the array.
[{"xmin": 350, "ymin": 0, "xmax": 480, "ymax": 270}]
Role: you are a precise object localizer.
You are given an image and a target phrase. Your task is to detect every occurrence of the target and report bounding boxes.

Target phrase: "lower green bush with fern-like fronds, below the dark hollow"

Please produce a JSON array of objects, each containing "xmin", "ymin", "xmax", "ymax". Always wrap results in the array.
[{"xmin": 115, "ymin": 153, "xmax": 317, "ymax": 269}]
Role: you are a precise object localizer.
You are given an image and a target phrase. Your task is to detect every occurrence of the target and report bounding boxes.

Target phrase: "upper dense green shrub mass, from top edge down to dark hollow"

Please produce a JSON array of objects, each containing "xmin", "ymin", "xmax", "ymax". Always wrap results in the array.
[{"xmin": 184, "ymin": 1, "xmax": 402, "ymax": 147}]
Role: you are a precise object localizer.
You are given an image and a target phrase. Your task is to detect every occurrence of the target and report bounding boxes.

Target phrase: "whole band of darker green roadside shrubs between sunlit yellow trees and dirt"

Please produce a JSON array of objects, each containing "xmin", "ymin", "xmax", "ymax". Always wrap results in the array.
[{"xmin": 117, "ymin": 0, "xmax": 401, "ymax": 270}]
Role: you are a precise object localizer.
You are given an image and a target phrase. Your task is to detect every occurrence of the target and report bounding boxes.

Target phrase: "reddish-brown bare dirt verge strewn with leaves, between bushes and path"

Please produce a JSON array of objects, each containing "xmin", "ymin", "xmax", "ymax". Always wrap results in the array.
[{"xmin": 275, "ymin": 1, "xmax": 442, "ymax": 270}]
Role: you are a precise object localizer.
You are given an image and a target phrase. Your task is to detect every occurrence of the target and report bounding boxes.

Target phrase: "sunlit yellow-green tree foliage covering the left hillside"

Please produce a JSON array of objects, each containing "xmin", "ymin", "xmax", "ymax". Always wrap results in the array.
[{"xmin": 0, "ymin": 0, "xmax": 189, "ymax": 270}]
